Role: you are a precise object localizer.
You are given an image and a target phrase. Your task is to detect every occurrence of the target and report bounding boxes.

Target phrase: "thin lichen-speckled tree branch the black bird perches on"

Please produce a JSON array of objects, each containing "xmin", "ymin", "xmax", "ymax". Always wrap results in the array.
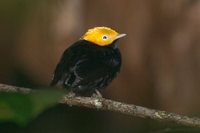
[{"xmin": 0, "ymin": 84, "xmax": 200, "ymax": 128}]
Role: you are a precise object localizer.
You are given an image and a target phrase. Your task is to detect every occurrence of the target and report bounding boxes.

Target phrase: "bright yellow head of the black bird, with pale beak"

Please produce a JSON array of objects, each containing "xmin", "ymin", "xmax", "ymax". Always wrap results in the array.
[{"xmin": 81, "ymin": 27, "xmax": 126, "ymax": 46}]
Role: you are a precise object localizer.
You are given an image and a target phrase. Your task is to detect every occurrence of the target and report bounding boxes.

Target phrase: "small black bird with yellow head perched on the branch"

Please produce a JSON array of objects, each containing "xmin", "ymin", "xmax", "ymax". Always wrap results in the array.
[{"xmin": 50, "ymin": 26, "xmax": 126, "ymax": 96}]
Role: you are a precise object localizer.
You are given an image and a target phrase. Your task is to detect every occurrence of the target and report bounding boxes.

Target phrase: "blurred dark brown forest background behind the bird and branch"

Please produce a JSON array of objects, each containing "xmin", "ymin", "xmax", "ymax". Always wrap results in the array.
[{"xmin": 0, "ymin": 0, "xmax": 200, "ymax": 133}]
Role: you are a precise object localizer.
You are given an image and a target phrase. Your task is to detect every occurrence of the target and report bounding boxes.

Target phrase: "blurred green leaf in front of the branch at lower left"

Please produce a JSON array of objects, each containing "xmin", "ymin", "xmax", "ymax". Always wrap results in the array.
[{"xmin": 0, "ymin": 89, "xmax": 65, "ymax": 126}]
